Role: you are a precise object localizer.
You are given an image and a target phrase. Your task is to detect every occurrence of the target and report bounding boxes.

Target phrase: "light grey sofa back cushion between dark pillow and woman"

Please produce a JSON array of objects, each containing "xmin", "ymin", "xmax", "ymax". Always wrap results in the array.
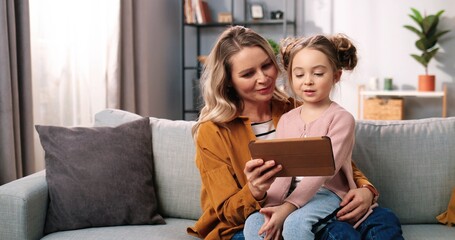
[{"xmin": 95, "ymin": 109, "xmax": 201, "ymax": 219}]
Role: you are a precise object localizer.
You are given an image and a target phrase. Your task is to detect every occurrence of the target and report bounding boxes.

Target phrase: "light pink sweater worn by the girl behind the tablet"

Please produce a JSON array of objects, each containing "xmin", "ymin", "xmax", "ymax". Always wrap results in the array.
[{"xmin": 266, "ymin": 102, "xmax": 357, "ymax": 208}]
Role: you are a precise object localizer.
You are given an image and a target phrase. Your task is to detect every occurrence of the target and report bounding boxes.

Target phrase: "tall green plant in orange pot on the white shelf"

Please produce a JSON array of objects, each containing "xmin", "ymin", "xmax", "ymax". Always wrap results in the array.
[{"xmin": 404, "ymin": 8, "xmax": 449, "ymax": 91}]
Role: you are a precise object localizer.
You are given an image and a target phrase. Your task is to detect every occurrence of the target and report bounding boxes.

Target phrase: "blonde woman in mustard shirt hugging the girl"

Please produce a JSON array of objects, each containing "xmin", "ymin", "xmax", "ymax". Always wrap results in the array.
[{"xmin": 187, "ymin": 26, "xmax": 402, "ymax": 239}]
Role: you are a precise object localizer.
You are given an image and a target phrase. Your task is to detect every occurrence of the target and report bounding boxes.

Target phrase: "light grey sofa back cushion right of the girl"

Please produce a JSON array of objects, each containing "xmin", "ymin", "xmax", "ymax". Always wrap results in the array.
[{"xmin": 353, "ymin": 117, "xmax": 455, "ymax": 224}]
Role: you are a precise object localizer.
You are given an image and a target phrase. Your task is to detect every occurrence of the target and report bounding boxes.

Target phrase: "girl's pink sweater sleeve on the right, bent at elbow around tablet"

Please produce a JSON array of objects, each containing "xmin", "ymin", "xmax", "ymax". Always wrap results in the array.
[{"xmin": 284, "ymin": 112, "xmax": 355, "ymax": 208}]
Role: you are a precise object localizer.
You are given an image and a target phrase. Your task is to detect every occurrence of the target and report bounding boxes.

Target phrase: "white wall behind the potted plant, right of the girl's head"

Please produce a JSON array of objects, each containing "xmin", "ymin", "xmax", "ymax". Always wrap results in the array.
[{"xmin": 298, "ymin": 0, "xmax": 455, "ymax": 119}]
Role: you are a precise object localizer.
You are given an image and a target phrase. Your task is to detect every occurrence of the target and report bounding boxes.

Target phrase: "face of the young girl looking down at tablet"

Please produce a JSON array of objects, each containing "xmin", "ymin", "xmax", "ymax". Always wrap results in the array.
[{"xmin": 291, "ymin": 48, "xmax": 341, "ymax": 105}]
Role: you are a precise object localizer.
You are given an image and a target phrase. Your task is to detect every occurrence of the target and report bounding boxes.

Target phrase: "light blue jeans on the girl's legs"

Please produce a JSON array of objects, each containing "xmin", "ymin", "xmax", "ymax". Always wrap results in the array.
[{"xmin": 243, "ymin": 188, "xmax": 341, "ymax": 240}]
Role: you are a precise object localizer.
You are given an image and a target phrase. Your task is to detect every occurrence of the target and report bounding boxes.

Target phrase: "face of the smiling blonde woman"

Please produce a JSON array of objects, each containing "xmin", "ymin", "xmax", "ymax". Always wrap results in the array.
[{"xmin": 230, "ymin": 47, "xmax": 278, "ymax": 106}]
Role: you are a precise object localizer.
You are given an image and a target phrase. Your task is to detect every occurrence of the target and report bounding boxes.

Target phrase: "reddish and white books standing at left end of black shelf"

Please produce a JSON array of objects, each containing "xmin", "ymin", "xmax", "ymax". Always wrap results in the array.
[{"xmin": 184, "ymin": 0, "xmax": 212, "ymax": 24}]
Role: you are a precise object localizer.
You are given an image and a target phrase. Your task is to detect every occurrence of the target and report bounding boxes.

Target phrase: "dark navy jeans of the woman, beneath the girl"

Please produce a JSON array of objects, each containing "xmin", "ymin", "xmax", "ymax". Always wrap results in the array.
[{"xmin": 315, "ymin": 207, "xmax": 404, "ymax": 240}]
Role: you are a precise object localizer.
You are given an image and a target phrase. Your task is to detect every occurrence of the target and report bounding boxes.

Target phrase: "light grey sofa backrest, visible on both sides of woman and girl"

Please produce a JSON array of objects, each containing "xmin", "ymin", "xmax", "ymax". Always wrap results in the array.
[{"xmin": 95, "ymin": 109, "xmax": 455, "ymax": 224}]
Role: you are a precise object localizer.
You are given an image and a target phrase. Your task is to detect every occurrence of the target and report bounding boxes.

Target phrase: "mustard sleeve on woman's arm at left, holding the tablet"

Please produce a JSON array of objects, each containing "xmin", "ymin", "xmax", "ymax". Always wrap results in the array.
[{"xmin": 196, "ymin": 125, "xmax": 261, "ymax": 226}]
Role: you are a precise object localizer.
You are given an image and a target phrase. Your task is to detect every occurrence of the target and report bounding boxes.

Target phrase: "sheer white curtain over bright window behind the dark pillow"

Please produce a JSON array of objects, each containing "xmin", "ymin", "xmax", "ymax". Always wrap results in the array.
[{"xmin": 30, "ymin": 0, "xmax": 120, "ymax": 168}]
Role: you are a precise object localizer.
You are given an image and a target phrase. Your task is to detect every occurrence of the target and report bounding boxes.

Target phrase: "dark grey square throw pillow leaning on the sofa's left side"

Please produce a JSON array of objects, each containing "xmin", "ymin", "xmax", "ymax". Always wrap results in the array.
[{"xmin": 36, "ymin": 118, "xmax": 165, "ymax": 234}]
